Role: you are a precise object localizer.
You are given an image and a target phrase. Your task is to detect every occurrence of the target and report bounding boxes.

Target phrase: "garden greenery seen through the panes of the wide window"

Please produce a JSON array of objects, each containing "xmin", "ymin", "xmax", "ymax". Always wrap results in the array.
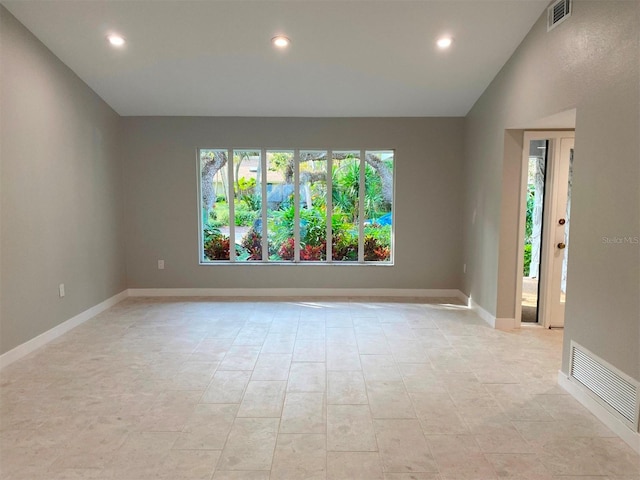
[{"xmin": 202, "ymin": 152, "xmax": 393, "ymax": 262}]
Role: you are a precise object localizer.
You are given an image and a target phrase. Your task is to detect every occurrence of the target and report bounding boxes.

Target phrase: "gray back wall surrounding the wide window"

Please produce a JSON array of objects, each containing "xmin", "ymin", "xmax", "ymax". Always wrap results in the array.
[{"xmin": 123, "ymin": 117, "xmax": 463, "ymax": 289}]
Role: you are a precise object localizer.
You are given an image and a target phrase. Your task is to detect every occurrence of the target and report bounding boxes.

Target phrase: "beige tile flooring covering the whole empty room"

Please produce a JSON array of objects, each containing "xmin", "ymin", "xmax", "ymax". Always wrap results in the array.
[{"xmin": 0, "ymin": 298, "xmax": 640, "ymax": 480}]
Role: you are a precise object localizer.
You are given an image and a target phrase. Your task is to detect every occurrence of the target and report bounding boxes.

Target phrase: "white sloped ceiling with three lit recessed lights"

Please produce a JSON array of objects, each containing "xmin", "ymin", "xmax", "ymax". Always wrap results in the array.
[{"xmin": 2, "ymin": 0, "xmax": 548, "ymax": 116}]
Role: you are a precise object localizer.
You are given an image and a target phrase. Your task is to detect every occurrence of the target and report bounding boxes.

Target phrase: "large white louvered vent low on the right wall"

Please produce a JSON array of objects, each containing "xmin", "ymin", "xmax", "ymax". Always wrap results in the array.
[{"xmin": 569, "ymin": 342, "xmax": 640, "ymax": 432}]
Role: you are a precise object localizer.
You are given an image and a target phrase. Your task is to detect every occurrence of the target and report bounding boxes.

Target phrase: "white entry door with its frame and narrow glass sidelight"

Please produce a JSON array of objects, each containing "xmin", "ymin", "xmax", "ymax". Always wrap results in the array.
[{"xmin": 516, "ymin": 131, "xmax": 574, "ymax": 328}]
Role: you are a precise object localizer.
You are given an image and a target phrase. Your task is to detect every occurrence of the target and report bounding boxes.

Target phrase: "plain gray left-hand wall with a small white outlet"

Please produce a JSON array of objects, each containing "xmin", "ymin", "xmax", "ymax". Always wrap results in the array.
[{"xmin": 0, "ymin": 6, "xmax": 126, "ymax": 353}]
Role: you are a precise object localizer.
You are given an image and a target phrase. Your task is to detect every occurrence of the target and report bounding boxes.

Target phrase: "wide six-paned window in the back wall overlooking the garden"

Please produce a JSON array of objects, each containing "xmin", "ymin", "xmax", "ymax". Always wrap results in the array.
[{"xmin": 198, "ymin": 148, "xmax": 394, "ymax": 264}]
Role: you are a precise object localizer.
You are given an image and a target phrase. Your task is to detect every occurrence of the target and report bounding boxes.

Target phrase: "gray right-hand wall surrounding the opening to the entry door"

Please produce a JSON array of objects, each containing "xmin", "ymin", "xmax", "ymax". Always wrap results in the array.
[{"xmin": 463, "ymin": 1, "xmax": 640, "ymax": 379}]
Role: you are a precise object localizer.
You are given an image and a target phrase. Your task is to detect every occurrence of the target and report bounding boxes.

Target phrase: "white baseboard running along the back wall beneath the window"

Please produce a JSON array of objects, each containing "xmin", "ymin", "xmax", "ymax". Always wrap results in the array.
[{"xmin": 128, "ymin": 288, "xmax": 466, "ymax": 301}]
